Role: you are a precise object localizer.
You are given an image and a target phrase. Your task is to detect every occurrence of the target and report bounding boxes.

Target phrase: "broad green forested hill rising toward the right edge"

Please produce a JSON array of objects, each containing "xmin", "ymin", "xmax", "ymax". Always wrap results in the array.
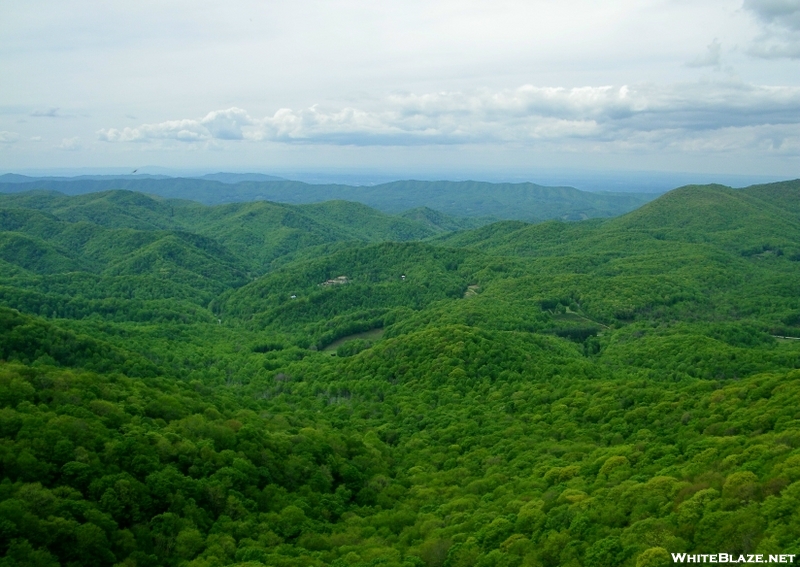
[{"xmin": 437, "ymin": 181, "xmax": 800, "ymax": 255}]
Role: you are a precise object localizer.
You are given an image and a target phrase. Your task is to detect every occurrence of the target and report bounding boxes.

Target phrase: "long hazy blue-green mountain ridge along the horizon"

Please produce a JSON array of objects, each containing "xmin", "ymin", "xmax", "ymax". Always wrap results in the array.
[{"xmin": 0, "ymin": 178, "xmax": 656, "ymax": 221}]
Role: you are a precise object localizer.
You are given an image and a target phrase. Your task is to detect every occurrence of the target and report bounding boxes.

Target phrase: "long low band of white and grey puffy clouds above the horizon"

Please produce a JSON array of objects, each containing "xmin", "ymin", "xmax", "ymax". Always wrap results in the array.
[{"xmin": 98, "ymin": 81, "xmax": 800, "ymax": 154}]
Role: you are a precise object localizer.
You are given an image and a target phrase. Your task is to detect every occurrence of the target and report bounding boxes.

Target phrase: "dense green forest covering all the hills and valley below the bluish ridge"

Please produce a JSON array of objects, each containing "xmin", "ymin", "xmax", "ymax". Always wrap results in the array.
[{"xmin": 0, "ymin": 180, "xmax": 800, "ymax": 567}]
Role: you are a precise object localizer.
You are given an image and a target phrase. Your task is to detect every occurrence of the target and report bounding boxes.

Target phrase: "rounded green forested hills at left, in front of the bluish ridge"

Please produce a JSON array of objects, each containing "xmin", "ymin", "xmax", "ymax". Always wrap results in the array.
[{"xmin": 0, "ymin": 191, "xmax": 485, "ymax": 276}]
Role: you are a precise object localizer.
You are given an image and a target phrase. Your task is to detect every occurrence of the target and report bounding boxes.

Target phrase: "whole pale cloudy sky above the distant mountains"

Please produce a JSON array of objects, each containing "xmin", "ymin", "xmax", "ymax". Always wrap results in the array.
[{"xmin": 0, "ymin": 0, "xmax": 800, "ymax": 183}]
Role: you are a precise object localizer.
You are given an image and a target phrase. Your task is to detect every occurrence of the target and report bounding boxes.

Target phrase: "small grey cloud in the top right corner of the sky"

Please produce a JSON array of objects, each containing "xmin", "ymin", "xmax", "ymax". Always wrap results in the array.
[{"xmin": 742, "ymin": 0, "xmax": 800, "ymax": 59}]
